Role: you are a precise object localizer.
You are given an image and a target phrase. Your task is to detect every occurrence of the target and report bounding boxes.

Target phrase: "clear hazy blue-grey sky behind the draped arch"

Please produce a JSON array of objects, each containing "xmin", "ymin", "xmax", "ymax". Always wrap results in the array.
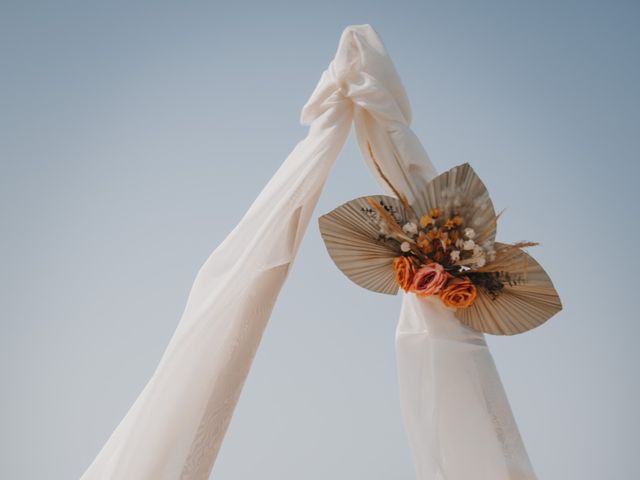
[{"xmin": 0, "ymin": 0, "xmax": 640, "ymax": 480}]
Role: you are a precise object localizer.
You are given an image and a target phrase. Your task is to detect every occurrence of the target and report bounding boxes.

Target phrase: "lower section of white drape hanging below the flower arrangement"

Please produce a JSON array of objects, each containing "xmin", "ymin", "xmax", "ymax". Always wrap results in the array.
[{"xmin": 396, "ymin": 294, "xmax": 536, "ymax": 480}]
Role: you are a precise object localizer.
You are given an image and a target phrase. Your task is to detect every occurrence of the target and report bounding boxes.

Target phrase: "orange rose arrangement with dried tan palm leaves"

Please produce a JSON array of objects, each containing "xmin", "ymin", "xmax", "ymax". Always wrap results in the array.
[{"xmin": 320, "ymin": 161, "xmax": 562, "ymax": 335}]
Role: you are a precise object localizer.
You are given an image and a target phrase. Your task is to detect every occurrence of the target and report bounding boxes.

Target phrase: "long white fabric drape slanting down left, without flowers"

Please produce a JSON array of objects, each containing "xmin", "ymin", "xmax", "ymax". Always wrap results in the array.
[{"xmin": 82, "ymin": 24, "xmax": 388, "ymax": 480}]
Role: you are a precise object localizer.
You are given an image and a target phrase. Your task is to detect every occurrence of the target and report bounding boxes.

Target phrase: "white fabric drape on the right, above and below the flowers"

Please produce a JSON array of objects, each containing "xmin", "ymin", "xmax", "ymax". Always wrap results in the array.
[{"xmin": 324, "ymin": 26, "xmax": 536, "ymax": 480}]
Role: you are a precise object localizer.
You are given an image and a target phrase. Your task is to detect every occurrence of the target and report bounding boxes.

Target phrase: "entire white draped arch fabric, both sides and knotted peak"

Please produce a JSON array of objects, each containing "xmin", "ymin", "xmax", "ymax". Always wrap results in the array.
[{"xmin": 82, "ymin": 25, "xmax": 535, "ymax": 480}]
